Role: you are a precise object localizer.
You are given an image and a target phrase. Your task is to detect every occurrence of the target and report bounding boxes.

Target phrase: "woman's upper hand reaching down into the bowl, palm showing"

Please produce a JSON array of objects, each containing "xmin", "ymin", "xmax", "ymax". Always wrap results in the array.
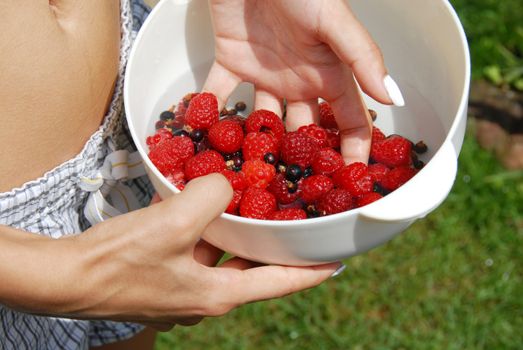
[{"xmin": 204, "ymin": 0, "xmax": 403, "ymax": 163}]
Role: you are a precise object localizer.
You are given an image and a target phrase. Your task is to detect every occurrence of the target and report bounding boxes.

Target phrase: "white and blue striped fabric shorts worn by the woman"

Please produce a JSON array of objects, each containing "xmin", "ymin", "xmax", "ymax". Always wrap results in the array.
[{"xmin": 0, "ymin": 0, "xmax": 152, "ymax": 350}]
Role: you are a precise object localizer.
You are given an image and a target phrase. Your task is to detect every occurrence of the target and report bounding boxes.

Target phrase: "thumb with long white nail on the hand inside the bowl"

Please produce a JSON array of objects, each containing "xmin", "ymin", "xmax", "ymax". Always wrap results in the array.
[{"xmin": 320, "ymin": 1, "xmax": 405, "ymax": 106}]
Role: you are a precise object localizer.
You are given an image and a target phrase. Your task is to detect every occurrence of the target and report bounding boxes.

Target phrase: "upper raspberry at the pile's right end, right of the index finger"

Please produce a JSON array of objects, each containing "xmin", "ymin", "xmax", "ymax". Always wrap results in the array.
[{"xmin": 370, "ymin": 135, "xmax": 412, "ymax": 168}]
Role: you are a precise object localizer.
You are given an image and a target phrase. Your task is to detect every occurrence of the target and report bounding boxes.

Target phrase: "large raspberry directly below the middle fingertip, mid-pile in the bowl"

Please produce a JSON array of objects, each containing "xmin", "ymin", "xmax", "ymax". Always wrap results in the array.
[{"xmin": 281, "ymin": 131, "xmax": 320, "ymax": 169}]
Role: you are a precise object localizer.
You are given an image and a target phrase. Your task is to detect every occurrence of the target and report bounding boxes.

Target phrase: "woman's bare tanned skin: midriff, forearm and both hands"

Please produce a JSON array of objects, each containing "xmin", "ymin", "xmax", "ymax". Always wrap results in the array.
[{"xmin": 0, "ymin": 0, "xmax": 390, "ymax": 349}]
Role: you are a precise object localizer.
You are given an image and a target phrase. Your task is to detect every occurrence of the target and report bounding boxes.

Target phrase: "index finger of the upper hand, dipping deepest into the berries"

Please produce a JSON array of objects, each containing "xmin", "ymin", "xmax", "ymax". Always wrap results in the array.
[{"xmin": 327, "ymin": 69, "xmax": 372, "ymax": 164}]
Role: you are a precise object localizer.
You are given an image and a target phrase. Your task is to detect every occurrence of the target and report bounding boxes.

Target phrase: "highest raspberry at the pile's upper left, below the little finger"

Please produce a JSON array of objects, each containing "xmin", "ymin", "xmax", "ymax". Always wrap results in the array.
[{"xmin": 185, "ymin": 92, "xmax": 220, "ymax": 130}]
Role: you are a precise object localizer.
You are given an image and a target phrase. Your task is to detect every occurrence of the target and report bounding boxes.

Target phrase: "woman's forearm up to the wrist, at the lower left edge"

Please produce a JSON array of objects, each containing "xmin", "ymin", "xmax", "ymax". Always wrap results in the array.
[{"xmin": 0, "ymin": 226, "xmax": 83, "ymax": 315}]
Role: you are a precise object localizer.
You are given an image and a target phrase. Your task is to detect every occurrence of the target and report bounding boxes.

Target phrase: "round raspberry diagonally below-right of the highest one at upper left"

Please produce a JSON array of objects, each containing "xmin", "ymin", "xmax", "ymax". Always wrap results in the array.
[{"xmin": 208, "ymin": 120, "xmax": 243, "ymax": 153}]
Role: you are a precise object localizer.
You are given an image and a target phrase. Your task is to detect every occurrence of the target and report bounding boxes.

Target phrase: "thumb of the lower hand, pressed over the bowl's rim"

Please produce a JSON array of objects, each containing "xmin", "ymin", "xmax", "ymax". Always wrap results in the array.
[{"xmin": 156, "ymin": 174, "xmax": 232, "ymax": 237}]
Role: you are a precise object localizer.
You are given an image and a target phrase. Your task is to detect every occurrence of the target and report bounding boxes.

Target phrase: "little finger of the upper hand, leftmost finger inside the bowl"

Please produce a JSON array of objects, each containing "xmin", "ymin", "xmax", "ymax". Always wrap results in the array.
[{"xmin": 202, "ymin": 61, "xmax": 241, "ymax": 111}]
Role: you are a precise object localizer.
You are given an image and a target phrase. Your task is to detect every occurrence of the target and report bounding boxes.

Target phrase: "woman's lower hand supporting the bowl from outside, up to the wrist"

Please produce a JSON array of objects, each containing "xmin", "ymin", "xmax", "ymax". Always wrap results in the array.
[{"xmin": 67, "ymin": 174, "xmax": 339, "ymax": 330}]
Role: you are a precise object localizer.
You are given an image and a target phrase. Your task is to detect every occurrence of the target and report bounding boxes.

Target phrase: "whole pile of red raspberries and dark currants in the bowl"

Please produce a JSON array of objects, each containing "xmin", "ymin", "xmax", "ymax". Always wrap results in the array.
[{"xmin": 146, "ymin": 93, "xmax": 427, "ymax": 220}]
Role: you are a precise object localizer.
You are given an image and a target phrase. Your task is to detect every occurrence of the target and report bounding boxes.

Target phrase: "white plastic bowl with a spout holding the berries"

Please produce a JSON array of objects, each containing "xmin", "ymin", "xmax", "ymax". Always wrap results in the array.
[{"xmin": 124, "ymin": 0, "xmax": 470, "ymax": 265}]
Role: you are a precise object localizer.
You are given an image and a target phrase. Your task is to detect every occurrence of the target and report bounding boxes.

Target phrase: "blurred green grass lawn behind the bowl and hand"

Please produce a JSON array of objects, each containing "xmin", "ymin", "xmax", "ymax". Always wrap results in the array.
[{"xmin": 140, "ymin": 0, "xmax": 523, "ymax": 350}]
